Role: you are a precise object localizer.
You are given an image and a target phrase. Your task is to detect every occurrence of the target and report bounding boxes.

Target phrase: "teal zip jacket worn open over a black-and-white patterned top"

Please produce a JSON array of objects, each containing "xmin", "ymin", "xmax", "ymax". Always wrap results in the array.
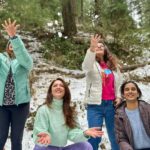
[{"xmin": 0, "ymin": 36, "xmax": 33, "ymax": 106}]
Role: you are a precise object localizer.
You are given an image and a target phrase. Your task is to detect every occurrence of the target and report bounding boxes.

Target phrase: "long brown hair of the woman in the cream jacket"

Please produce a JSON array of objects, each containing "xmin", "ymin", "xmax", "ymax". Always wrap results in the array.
[{"xmin": 96, "ymin": 41, "xmax": 119, "ymax": 70}]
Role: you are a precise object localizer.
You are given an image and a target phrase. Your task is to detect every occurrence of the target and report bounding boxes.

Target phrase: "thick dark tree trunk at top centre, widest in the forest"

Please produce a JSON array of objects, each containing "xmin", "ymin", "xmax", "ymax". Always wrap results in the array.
[{"xmin": 62, "ymin": 0, "xmax": 77, "ymax": 36}]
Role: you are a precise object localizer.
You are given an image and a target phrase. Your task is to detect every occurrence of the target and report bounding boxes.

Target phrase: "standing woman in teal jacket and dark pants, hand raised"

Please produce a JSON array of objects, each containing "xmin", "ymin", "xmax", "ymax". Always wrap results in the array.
[{"xmin": 0, "ymin": 19, "xmax": 33, "ymax": 150}]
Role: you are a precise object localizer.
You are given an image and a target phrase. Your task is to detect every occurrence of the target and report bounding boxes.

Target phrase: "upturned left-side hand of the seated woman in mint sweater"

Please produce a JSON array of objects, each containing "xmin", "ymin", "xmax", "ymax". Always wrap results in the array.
[{"xmin": 37, "ymin": 132, "xmax": 51, "ymax": 145}]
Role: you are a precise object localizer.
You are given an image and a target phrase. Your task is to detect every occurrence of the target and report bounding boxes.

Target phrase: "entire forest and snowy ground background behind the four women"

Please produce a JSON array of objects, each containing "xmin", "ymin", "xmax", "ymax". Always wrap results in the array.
[{"xmin": 0, "ymin": 0, "xmax": 150, "ymax": 150}]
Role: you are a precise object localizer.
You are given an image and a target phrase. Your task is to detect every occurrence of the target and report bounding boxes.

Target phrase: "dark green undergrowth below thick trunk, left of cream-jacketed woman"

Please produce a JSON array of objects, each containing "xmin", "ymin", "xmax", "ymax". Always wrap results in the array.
[{"xmin": 43, "ymin": 36, "xmax": 88, "ymax": 69}]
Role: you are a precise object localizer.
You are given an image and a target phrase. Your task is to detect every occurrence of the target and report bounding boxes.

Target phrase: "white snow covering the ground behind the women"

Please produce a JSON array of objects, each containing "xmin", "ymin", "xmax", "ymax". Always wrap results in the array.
[{"xmin": 5, "ymin": 33, "xmax": 150, "ymax": 150}]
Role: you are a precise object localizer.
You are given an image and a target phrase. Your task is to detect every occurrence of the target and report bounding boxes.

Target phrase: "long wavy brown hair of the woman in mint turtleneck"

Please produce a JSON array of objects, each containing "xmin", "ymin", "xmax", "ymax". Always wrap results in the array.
[{"xmin": 45, "ymin": 78, "xmax": 76, "ymax": 128}]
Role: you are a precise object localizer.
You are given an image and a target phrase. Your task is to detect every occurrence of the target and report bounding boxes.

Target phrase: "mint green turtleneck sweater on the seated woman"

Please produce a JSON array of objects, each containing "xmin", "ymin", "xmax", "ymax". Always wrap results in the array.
[{"xmin": 33, "ymin": 99, "xmax": 87, "ymax": 147}]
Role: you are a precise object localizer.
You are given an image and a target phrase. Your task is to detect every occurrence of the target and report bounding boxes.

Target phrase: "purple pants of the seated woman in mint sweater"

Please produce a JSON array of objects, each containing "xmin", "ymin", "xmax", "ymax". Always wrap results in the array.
[{"xmin": 33, "ymin": 142, "xmax": 93, "ymax": 150}]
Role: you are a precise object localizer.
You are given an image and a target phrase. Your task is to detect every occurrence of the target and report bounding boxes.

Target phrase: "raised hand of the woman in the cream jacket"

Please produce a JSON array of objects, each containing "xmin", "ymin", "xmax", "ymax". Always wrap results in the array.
[{"xmin": 90, "ymin": 34, "xmax": 101, "ymax": 52}]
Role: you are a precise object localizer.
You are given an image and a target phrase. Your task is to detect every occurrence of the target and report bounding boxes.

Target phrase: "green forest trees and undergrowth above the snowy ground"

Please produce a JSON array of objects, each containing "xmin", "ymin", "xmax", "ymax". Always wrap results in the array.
[{"xmin": 0, "ymin": 0, "xmax": 150, "ymax": 69}]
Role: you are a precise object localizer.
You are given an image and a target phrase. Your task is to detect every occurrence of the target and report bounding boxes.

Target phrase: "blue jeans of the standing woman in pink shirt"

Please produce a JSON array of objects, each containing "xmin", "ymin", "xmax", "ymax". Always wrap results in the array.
[{"xmin": 87, "ymin": 100, "xmax": 119, "ymax": 150}]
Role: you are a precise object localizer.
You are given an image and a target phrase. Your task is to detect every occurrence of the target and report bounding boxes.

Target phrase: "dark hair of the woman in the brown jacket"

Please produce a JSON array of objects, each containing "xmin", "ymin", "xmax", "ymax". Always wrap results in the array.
[{"xmin": 120, "ymin": 81, "xmax": 142, "ymax": 99}]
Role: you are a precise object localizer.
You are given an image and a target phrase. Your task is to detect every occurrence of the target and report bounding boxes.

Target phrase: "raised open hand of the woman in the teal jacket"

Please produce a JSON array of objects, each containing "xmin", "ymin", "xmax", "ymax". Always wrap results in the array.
[{"xmin": 2, "ymin": 18, "xmax": 20, "ymax": 37}]
